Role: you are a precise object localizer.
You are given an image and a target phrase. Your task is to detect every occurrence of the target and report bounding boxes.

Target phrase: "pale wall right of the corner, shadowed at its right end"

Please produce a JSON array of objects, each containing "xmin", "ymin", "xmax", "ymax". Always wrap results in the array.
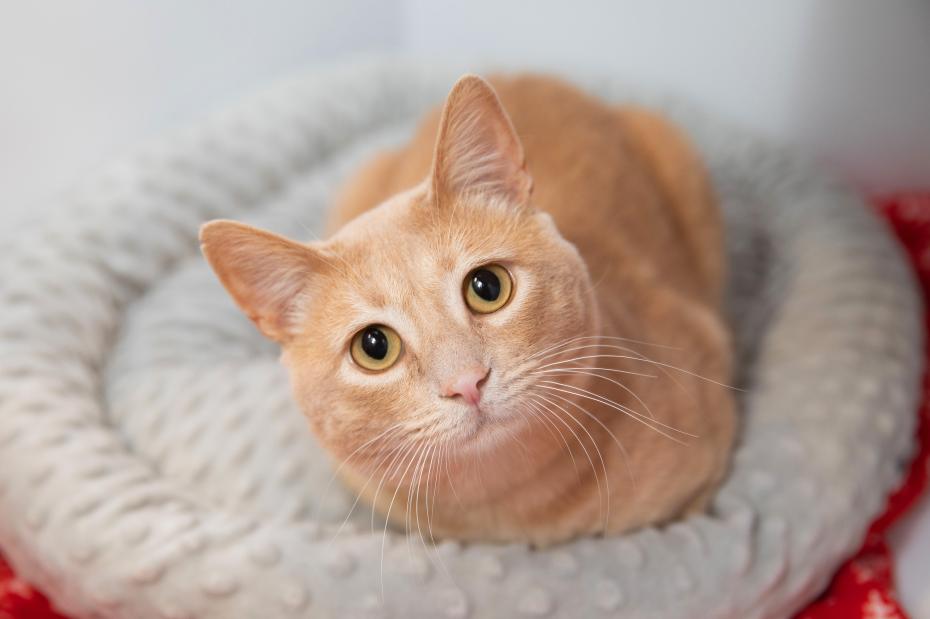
[{"xmin": 403, "ymin": 0, "xmax": 930, "ymax": 190}]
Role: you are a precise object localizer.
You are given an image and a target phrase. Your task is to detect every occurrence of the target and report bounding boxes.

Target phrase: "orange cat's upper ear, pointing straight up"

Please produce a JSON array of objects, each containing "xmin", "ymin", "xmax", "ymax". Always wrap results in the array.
[{"xmin": 430, "ymin": 75, "xmax": 533, "ymax": 206}]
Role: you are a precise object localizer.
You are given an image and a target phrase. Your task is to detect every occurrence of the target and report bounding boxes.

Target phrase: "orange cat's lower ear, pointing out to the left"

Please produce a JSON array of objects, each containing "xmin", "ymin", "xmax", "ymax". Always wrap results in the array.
[{"xmin": 200, "ymin": 219, "xmax": 326, "ymax": 343}]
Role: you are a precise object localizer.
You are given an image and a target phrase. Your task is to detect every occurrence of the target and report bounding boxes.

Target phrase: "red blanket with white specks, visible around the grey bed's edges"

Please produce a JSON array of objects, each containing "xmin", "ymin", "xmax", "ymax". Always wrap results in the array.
[{"xmin": 0, "ymin": 195, "xmax": 930, "ymax": 619}]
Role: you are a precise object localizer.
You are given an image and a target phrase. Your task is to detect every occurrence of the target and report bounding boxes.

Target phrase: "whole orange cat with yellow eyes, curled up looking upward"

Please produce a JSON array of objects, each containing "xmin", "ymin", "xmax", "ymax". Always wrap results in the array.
[{"xmin": 200, "ymin": 75, "xmax": 737, "ymax": 546}]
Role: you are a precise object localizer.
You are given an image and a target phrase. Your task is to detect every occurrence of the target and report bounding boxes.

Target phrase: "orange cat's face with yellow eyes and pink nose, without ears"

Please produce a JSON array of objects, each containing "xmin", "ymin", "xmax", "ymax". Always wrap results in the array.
[{"xmin": 285, "ymin": 189, "xmax": 594, "ymax": 464}]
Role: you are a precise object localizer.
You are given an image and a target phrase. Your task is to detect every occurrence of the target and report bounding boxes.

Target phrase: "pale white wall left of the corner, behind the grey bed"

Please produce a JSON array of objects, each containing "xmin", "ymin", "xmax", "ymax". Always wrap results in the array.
[{"xmin": 0, "ymin": 0, "xmax": 402, "ymax": 232}]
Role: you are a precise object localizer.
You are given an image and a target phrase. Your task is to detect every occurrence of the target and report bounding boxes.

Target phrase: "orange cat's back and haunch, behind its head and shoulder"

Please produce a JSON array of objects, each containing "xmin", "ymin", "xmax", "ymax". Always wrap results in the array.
[{"xmin": 330, "ymin": 74, "xmax": 723, "ymax": 301}]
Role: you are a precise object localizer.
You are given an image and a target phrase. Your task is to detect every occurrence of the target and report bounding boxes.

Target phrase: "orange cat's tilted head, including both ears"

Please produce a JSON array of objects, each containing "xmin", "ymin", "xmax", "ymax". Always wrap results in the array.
[{"xmin": 201, "ymin": 76, "xmax": 597, "ymax": 474}]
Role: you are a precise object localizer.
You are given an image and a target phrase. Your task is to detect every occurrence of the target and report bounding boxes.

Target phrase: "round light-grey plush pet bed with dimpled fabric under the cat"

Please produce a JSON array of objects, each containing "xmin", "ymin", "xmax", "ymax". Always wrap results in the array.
[{"xmin": 0, "ymin": 63, "xmax": 923, "ymax": 619}]
